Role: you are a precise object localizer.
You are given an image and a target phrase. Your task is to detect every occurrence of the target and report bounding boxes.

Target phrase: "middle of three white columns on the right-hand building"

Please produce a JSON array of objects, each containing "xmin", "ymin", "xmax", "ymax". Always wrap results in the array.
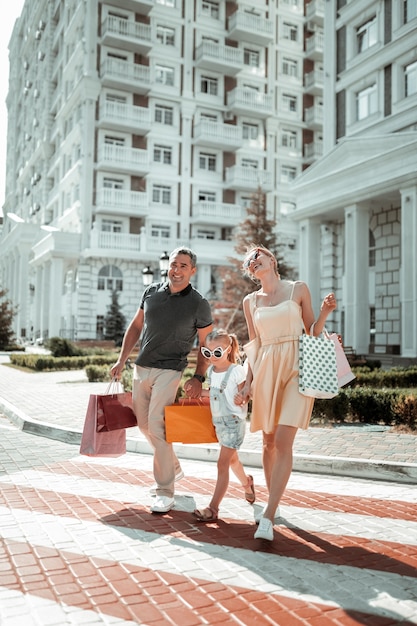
[{"xmin": 343, "ymin": 204, "xmax": 369, "ymax": 354}]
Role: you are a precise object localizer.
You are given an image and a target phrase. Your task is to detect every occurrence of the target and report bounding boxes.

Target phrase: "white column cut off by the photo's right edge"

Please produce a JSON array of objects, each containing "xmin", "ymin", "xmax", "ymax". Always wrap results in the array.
[{"xmin": 400, "ymin": 186, "xmax": 417, "ymax": 357}]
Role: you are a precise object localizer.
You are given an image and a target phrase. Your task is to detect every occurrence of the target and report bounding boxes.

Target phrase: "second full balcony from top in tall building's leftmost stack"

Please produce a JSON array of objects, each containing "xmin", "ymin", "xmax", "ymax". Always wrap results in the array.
[{"xmin": 100, "ymin": 58, "xmax": 151, "ymax": 95}]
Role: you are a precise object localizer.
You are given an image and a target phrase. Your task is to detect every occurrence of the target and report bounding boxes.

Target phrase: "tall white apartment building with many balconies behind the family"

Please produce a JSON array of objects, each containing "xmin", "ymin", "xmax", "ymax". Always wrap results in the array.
[{"xmin": 0, "ymin": 0, "xmax": 308, "ymax": 340}]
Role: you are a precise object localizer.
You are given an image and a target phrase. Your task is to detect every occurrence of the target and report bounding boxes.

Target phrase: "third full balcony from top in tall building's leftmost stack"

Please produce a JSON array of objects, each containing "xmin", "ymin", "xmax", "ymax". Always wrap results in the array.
[{"xmin": 98, "ymin": 101, "xmax": 151, "ymax": 135}]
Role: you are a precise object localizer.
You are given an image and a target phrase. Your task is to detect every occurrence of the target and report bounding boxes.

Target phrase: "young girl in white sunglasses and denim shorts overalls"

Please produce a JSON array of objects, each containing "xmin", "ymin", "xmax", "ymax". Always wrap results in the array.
[{"xmin": 193, "ymin": 330, "xmax": 255, "ymax": 522}]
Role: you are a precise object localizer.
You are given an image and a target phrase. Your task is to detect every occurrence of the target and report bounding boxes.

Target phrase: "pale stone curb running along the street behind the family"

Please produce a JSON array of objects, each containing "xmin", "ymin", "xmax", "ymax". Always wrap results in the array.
[{"xmin": 0, "ymin": 399, "xmax": 417, "ymax": 484}]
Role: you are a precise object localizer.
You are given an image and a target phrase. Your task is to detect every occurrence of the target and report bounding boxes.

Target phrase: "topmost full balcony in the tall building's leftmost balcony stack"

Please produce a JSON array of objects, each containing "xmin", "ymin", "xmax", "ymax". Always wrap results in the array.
[{"xmin": 101, "ymin": 15, "xmax": 152, "ymax": 54}]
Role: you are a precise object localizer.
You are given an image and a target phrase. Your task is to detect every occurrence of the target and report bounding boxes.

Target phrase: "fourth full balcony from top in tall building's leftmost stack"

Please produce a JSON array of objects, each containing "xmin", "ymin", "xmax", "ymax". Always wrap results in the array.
[{"xmin": 97, "ymin": 144, "xmax": 149, "ymax": 176}]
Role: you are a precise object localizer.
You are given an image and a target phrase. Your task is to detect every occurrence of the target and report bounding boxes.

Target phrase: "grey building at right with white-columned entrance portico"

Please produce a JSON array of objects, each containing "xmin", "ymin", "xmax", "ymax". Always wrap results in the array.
[{"xmin": 293, "ymin": 0, "xmax": 417, "ymax": 362}]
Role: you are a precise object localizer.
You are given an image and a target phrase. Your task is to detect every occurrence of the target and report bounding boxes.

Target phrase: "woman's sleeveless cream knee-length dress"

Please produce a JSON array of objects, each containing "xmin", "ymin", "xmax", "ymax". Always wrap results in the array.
[{"xmin": 248, "ymin": 283, "xmax": 314, "ymax": 433}]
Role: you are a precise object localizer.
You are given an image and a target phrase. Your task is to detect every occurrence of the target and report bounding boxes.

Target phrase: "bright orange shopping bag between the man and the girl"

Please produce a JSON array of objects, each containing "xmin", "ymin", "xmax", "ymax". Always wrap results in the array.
[{"xmin": 165, "ymin": 398, "xmax": 217, "ymax": 443}]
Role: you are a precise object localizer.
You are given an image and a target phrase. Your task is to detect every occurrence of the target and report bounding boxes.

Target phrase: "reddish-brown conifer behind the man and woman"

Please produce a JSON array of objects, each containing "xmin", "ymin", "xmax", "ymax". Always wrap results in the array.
[{"xmin": 212, "ymin": 188, "xmax": 294, "ymax": 344}]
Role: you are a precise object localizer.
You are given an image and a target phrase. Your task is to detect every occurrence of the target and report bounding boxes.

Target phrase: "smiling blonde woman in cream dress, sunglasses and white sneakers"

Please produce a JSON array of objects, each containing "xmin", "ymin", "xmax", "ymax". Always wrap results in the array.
[{"xmin": 236, "ymin": 246, "xmax": 336, "ymax": 541}]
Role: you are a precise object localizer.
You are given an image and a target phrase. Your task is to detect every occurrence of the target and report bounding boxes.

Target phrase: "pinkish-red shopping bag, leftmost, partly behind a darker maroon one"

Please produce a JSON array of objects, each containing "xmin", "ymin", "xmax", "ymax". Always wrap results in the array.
[{"xmin": 80, "ymin": 394, "xmax": 126, "ymax": 457}]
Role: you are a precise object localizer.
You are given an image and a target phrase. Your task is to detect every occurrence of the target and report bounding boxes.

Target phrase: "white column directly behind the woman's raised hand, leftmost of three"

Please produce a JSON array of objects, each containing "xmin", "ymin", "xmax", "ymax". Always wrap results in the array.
[{"xmin": 300, "ymin": 219, "xmax": 324, "ymax": 317}]
